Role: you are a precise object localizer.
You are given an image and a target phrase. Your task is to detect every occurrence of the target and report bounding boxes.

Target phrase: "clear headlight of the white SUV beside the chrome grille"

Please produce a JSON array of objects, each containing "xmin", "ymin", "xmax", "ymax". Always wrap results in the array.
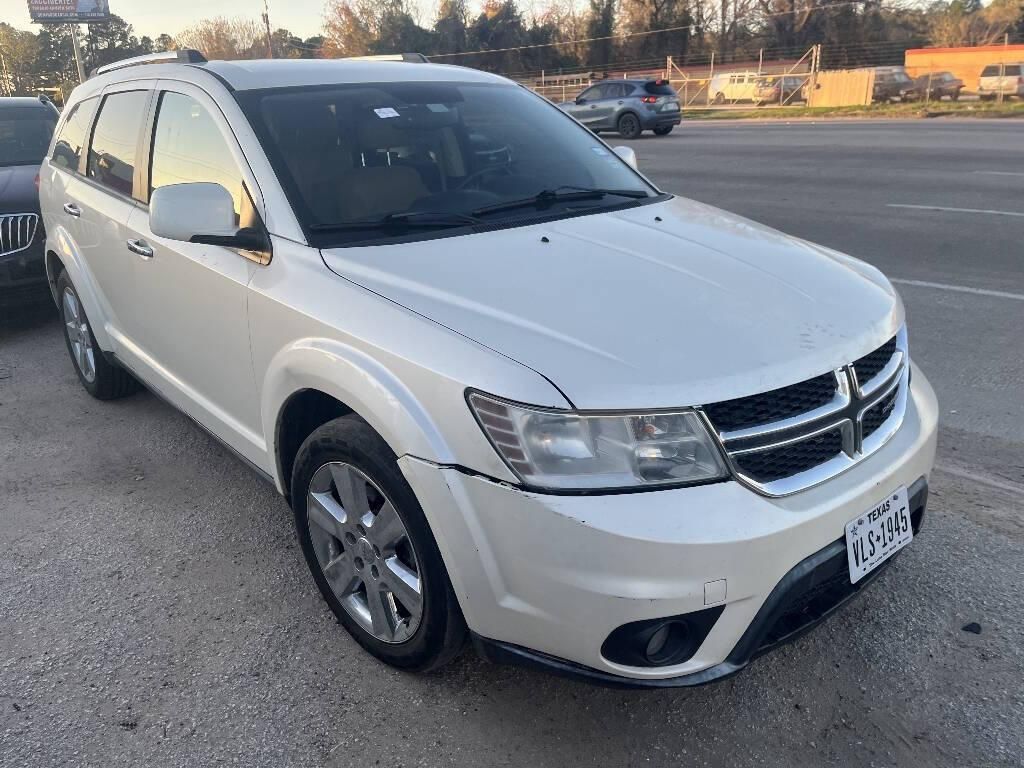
[{"xmin": 468, "ymin": 392, "xmax": 728, "ymax": 490}]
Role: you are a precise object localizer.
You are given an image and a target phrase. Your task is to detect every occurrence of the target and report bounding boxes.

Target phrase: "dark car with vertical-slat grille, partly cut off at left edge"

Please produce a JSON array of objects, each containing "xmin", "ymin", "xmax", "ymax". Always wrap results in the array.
[{"xmin": 0, "ymin": 97, "xmax": 58, "ymax": 306}]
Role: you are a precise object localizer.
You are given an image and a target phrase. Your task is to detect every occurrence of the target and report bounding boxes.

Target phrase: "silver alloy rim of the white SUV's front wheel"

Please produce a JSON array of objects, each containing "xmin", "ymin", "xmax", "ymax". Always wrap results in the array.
[{"xmin": 306, "ymin": 462, "xmax": 423, "ymax": 643}]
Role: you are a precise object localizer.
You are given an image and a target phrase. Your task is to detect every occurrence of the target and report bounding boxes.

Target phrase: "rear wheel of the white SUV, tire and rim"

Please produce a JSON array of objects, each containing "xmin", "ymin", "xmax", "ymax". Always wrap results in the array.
[{"xmin": 57, "ymin": 269, "xmax": 139, "ymax": 400}]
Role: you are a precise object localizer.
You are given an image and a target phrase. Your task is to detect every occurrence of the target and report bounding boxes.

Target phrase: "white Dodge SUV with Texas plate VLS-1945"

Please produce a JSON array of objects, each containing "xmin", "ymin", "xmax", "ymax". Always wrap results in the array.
[{"xmin": 41, "ymin": 51, "xmax": 936, "ymax": 686}]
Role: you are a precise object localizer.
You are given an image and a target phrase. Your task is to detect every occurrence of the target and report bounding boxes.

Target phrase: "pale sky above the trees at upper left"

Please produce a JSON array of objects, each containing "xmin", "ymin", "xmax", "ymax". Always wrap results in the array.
[{"xmin": 0, "ymin": 0, "xmax": 380, "ymax": 38}]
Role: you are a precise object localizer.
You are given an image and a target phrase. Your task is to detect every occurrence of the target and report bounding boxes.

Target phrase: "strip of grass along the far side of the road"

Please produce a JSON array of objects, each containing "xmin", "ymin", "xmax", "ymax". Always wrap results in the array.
[{"xmin": 683, "ymin": 101, "xmax": 1024, "ymax": 120}]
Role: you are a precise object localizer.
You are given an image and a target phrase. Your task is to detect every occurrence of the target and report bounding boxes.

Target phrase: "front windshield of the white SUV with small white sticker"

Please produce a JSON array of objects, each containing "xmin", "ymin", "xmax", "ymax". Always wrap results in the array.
[{"xmin": 236, "ymin": 82, "xmax": 657, "ymax": 247}]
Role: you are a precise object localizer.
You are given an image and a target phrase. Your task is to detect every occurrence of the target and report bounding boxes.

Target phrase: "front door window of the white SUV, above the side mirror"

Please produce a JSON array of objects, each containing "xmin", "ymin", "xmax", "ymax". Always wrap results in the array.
[{"xmin": 150, "ymin": 91, "xmax": 248, "ymax": 222}]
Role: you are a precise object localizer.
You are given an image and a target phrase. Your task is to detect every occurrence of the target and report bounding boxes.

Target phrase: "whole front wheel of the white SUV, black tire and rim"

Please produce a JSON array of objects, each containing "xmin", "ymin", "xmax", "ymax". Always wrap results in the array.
[{"xmin": 291, "ymin": 416, "xmax": 467, "ymax": 672}]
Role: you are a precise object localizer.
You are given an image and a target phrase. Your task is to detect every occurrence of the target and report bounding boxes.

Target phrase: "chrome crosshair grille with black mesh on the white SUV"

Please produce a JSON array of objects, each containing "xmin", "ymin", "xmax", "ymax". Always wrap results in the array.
[{"xmin": 702, "ymin": 329, "xmax": 910, "ymax": 496}]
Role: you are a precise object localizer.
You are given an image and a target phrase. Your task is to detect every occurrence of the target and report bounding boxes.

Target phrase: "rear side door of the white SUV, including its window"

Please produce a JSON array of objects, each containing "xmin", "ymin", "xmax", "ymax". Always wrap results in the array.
[{"xmin": 54, "ymin": 82, "xmax": 152, "ymax": 342}]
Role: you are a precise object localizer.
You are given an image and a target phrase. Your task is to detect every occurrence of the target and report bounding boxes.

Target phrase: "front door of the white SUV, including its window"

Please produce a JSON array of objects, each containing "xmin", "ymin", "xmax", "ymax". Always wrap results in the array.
[{"xmin": 120, "ymin": 81, "xmax": 268, "ymax": 463}]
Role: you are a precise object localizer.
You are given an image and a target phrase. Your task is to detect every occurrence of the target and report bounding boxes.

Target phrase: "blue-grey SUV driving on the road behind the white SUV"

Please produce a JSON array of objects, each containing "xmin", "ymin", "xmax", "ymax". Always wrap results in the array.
[{"xmin": 558, "ymin": 80, "xmax": 683, "ymax": 138}]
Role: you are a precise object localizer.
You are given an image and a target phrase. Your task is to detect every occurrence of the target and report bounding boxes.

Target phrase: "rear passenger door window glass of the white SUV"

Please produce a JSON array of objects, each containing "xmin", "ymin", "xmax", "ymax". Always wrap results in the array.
[{"xmin": 86, "ymin": 91, "xmax": 150, "ymax": 197}]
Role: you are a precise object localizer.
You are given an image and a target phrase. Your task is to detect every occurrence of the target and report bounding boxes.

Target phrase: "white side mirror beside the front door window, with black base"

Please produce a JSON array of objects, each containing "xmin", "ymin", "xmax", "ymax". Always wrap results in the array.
[{"xmin": 150, "ymin": 181, "xmax": 265, "ymax": 251}]
